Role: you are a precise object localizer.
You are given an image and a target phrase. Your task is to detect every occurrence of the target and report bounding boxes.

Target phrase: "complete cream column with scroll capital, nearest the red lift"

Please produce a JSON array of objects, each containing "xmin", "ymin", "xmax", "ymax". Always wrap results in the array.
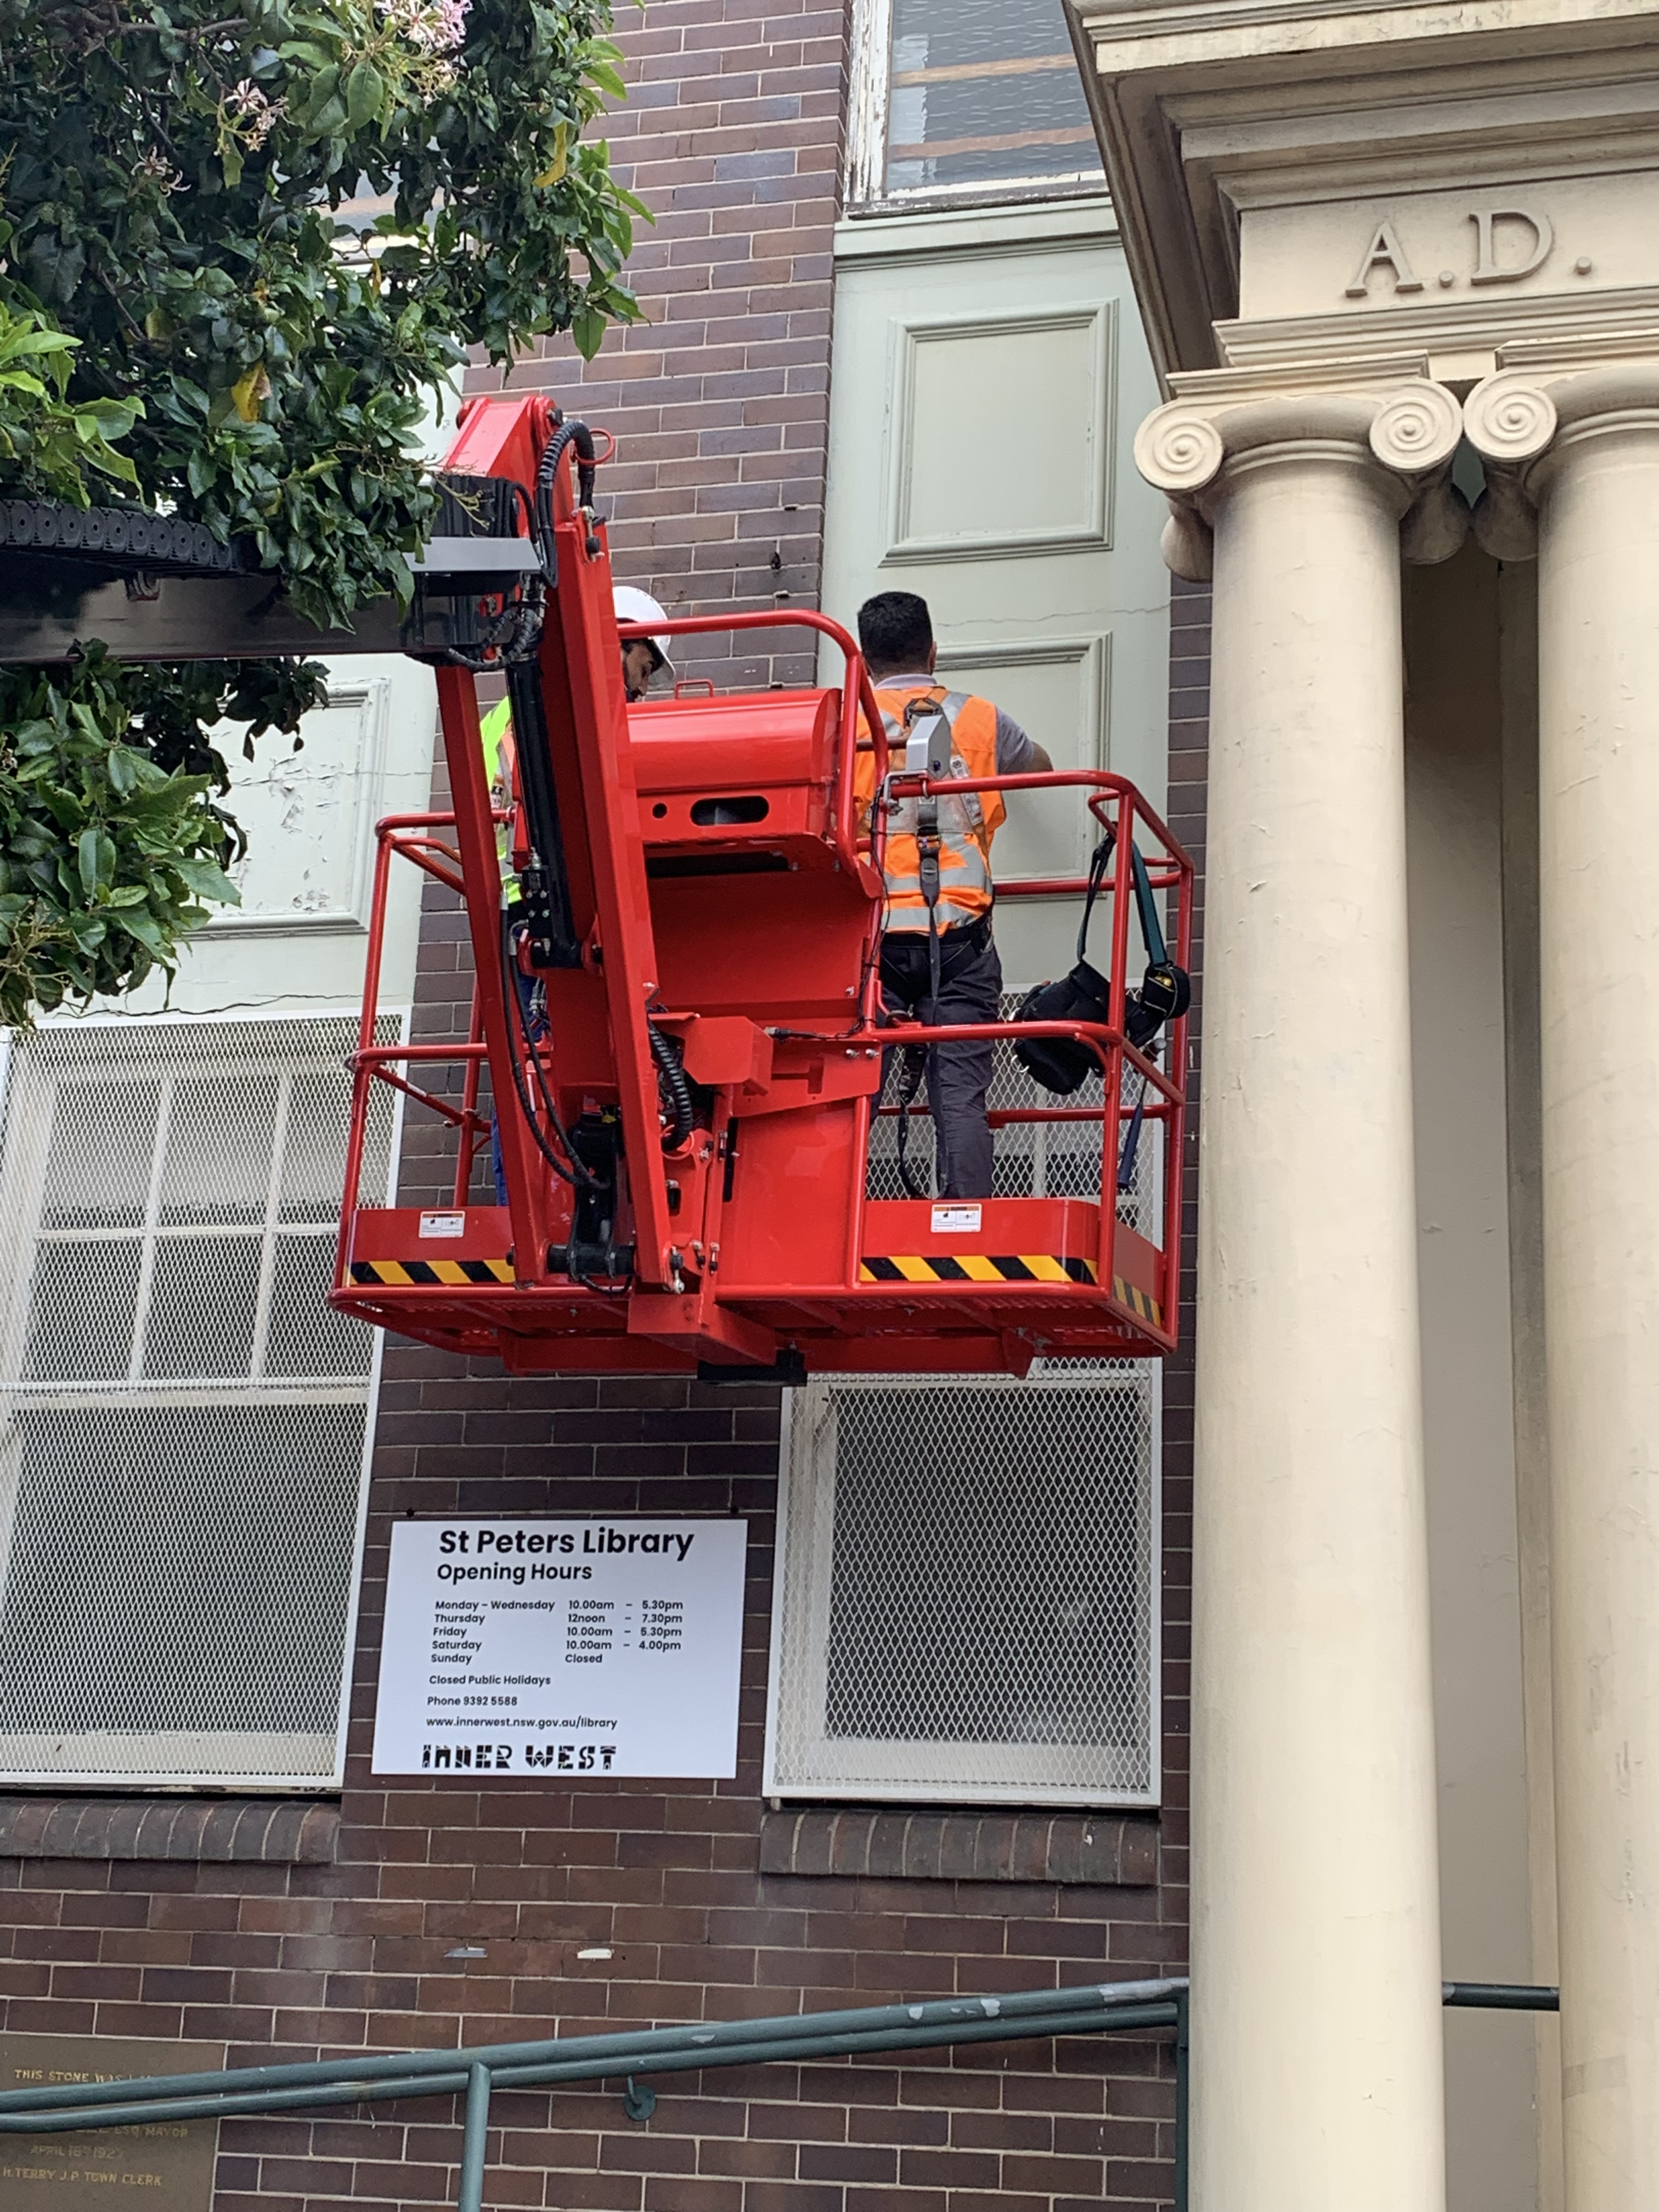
[{"xmin": 1137, "ymin": 371, "xmax": 1460, "ymax": 2212}]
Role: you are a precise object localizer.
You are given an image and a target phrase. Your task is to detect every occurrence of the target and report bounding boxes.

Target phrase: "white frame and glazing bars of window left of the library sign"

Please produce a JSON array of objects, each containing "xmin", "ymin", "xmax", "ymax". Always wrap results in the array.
[{"xmin": 0, "ymin": 1007, "xmax": 414, "ymax": 1796}]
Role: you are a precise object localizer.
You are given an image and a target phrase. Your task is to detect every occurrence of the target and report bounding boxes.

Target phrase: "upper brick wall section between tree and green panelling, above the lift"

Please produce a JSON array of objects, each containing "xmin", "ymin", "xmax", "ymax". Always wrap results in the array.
[{"xmin": 473, "ymin": 0, "xmax": 845, "ymax": 686}]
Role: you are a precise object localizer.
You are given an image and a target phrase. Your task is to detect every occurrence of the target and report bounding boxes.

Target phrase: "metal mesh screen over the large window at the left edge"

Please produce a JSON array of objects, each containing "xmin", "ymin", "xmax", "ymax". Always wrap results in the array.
[{"xmin": 0, "ymin": 1020, "xmax": 396, "ymax": 1783}]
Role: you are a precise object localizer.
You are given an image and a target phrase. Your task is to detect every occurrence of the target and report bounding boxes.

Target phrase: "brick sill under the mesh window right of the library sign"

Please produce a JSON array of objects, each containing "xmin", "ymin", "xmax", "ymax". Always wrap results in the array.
[{"xmin": 761, "ymin": 1807, "xmax": 1157, "ymax": 1889}]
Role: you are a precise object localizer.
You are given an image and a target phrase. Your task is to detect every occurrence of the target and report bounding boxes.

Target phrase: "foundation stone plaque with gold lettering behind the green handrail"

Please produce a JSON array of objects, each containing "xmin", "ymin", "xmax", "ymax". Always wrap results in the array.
[{"xmin": 0, "ymin": 2035, "xmax": 225, "ymax": 2212}]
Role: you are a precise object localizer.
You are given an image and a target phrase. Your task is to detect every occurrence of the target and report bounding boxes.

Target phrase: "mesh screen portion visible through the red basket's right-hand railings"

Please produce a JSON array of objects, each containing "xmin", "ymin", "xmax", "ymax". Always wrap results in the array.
[{"xmin": 865, "ymin": 991, "xmax": 1164, "ymax": 1243}]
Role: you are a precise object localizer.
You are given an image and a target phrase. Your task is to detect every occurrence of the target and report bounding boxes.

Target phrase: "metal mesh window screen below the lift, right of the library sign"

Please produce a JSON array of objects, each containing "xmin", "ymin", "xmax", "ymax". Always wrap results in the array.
[{"xmin": 768, "ymin": 1361, "xmax": 1157, "ymax": 1805}]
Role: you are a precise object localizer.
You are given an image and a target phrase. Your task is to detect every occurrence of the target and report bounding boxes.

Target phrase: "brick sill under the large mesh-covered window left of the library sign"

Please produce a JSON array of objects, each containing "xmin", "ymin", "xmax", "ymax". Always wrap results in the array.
[{"xmin": 0, "ymin": 1796, "xmax": 341, "ymax": 1867}]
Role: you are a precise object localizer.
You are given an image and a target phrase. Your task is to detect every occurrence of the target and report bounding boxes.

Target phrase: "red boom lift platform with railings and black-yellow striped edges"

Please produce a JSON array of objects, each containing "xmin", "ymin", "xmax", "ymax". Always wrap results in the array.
[{"xmin": 332, "ymin": 398, "xmax": 1192, "ymax": 1378}]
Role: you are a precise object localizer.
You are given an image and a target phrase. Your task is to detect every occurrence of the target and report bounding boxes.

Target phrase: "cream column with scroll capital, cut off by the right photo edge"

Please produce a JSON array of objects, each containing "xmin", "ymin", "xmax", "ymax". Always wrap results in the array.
[{"xmin": 1469, "ymin": 360, "xmax": 1659, "ymax": 2212}]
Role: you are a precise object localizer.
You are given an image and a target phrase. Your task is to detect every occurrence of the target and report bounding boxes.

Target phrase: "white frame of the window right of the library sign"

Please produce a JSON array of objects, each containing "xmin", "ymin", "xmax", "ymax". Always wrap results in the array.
[{"xmin": 761, "ymin": 1361, "xmax": 1164, "ymax": 1809}]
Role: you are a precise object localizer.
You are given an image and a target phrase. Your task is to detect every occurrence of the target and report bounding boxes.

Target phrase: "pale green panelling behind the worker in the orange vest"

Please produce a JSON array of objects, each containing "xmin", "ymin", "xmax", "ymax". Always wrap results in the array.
[{"xmin": 823, "ymin": 210, "xmax": 1168, "ymax": 984}]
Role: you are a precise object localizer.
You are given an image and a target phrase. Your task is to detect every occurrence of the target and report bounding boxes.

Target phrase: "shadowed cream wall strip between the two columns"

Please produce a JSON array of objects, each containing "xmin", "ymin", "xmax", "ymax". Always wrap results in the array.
[{"xmin": 1404, "ymin": 544, "xmax": 1539, "ymax": 2212}]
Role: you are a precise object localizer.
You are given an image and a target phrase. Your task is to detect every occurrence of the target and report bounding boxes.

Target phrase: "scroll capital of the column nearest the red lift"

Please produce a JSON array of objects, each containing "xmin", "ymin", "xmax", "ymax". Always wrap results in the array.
[{"xmin": 1135, "ymin": 369, "xmax": 1469, "ymax": 582}]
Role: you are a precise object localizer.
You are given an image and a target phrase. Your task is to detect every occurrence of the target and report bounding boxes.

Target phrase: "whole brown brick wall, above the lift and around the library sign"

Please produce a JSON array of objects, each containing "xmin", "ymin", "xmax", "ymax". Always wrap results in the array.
[{"xmin": 0, "ymin": 0, "xmax": 1207, "ymax": 2212}]
